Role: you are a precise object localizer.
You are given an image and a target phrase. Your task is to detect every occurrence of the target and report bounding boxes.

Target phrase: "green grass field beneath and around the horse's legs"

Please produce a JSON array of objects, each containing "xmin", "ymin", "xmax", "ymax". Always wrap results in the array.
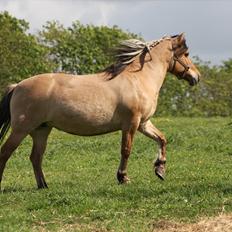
[{"xmin": 0, "ymin": 118, "xmax": 232, "ymax": 232}]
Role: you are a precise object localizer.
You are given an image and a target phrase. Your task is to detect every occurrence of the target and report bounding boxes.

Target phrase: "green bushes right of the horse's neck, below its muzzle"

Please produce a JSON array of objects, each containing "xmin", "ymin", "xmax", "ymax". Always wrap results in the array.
[{"xmin": 158, "ymin": 59, "xmax": 232, "ymax": 117}]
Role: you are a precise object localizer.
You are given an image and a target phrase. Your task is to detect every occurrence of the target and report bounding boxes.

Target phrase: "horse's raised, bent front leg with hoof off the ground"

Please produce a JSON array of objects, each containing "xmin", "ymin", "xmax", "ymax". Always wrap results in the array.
[{"xmin": 138, "ymin": 120, "xmax": 167, "ymax": 180}]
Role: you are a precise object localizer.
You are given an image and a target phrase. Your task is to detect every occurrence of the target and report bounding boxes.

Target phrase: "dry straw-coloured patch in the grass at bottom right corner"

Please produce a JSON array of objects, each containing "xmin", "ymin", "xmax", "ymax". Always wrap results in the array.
[{"xmin": 153, "ymin": 214, "xmax": 232, "ymax": 232}]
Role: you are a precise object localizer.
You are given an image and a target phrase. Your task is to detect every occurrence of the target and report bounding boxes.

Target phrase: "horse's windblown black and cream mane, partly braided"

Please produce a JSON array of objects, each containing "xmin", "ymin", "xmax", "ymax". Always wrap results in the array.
[{"xmin": 104, "ymin": 37, "xmax": 168, "ymax": 80}]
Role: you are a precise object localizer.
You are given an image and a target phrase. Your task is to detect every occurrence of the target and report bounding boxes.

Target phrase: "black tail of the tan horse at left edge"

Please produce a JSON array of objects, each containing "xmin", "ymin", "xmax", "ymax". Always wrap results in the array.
[{"xmin": 0, "ymin": 84, "xmax": 17, "ymax": 145}]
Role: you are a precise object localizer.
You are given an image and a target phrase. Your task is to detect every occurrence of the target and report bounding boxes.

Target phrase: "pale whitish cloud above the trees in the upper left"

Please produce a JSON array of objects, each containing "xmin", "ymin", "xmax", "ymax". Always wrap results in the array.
[{"xmin": 0, "ymin": 0, "xmax": 119, "ymax": 30}]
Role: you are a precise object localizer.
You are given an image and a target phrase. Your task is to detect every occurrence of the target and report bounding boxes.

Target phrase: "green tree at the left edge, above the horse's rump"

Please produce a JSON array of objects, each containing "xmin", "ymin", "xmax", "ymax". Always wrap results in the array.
[{"xmin": 0, "ymin": 12, "xmax": 53, "ymax": 91}]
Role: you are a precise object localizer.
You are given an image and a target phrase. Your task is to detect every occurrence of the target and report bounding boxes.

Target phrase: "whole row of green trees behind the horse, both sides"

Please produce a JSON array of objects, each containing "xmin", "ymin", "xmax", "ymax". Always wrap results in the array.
[{"xmin": 0, "ymin": 12, "xmax": 232, "ymax": 117}]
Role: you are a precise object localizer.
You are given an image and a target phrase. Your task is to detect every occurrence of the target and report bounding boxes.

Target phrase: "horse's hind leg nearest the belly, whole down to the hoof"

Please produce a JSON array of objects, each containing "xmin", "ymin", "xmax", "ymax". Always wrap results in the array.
[{"xmin": 30, "ymin": 126, "xmax": 52, "ymax": 188}]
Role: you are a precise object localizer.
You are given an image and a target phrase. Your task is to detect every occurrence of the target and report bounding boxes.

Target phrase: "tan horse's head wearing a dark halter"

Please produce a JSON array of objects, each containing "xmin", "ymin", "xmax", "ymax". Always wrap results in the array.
[{"xmin": 169, "ymin": 33, "xmax": 200, "ymax": 85}]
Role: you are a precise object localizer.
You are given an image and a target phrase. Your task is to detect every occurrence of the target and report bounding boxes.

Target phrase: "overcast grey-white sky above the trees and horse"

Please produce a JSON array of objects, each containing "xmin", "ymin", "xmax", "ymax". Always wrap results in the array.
[{"xmin": 0, "ymin": 0, "xmax": 232, "ymax": 64}]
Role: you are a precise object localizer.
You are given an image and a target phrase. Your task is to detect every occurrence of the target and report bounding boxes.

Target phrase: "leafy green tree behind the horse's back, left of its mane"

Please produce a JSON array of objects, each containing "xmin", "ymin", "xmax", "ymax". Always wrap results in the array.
[{"xmin": 39, "ymin": 21, "xmax": 138, "ymax": 74}]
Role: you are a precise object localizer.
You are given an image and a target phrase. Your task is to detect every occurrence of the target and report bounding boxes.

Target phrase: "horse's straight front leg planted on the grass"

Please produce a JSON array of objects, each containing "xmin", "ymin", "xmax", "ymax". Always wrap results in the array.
[{"xmin": 117, "ymin": 120, "xmax": 139, "ymax": 184}]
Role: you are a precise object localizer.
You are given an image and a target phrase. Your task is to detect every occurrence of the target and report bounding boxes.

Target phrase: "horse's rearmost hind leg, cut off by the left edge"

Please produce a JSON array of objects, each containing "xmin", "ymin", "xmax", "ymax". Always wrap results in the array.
[{"xmin": 0, "ymin": 131, "xmax": 27, "ymax": 189}]
